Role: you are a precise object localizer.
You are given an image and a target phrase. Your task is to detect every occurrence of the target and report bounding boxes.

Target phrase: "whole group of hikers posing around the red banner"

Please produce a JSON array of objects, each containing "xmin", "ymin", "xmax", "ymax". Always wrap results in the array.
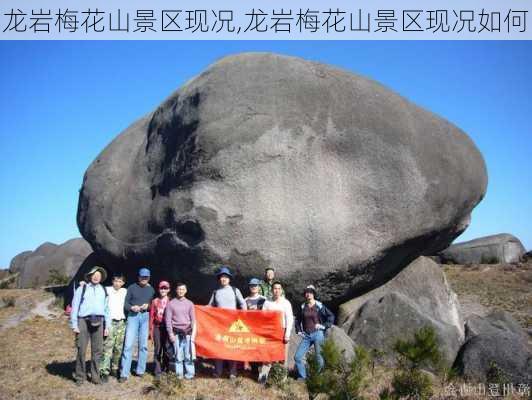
[{"xmin": 66, "ymin": 266, "xmax": 334, "ymax": 385}]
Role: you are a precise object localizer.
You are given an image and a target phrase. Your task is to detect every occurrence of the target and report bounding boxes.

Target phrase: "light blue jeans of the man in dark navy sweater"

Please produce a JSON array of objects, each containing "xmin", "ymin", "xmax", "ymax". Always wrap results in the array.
[{"xmin": 120, "ymin": 312, "xmax": 150, "ymax": 378}]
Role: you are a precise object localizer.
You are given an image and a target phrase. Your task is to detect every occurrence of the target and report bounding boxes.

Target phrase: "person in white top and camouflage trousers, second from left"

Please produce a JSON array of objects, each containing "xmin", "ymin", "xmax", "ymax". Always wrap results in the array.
[{"xmin": 100, "ymin": 275, "xmax": 127, "ymax": 383}]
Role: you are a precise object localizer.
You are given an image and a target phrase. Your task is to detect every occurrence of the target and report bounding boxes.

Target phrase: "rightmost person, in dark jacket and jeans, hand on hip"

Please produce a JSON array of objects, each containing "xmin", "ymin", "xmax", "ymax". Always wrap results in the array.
[{"xmin": 294, "ymin": 285, "xmax": 334, "ymax": 379}]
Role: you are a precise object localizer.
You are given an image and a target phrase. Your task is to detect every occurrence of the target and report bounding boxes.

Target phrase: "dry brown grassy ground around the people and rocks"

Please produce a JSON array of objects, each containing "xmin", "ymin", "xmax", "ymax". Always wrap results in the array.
[{"xmin": 0, "ymin": 263, "xmax": 532, "ymax": 400}]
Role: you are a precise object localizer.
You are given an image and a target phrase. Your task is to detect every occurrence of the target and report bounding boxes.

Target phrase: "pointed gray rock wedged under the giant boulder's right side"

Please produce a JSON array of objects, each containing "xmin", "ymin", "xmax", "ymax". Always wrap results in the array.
[{"xmin": 338, "ymin": 257, "xmax": 464, "ymax": 366}]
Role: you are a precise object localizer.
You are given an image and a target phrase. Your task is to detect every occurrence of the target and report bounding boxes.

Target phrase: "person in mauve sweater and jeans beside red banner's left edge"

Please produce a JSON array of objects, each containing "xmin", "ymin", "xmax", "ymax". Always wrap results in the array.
[{"xmin": 165, "ymin": 282, "xmax": 196, "ymax": 379}]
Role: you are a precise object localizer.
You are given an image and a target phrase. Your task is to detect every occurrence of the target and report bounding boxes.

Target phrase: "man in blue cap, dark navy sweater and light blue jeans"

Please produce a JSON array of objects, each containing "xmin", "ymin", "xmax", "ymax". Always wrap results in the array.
[{"xmin": 118, "ymin": 267, "xmax": 155, "ymax": 382}]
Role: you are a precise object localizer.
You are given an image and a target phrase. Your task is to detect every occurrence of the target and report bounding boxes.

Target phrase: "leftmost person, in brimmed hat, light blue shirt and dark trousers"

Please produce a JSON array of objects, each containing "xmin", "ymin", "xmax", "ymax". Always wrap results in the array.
[{"xmin": 70, "ymin": 266, "xmax": 111, "ymax": 385}]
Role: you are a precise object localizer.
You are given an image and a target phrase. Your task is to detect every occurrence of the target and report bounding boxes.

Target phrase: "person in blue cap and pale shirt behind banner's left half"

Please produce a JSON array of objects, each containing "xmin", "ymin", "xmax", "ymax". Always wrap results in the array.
[{"xmin": 208, "ymin": 266, "xmax": 247, "ymax": 379}]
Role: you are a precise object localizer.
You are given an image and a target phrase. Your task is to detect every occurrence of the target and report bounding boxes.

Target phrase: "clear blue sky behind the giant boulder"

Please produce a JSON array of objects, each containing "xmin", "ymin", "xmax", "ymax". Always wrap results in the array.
[{"xmin": 0, "ymin": 41, "xmax": 532, "ymax": 267}]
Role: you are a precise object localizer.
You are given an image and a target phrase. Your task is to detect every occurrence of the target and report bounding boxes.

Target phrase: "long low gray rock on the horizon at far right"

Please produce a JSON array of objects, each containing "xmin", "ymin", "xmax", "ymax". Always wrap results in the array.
[{"xmin": 439, "ymin": 233, "xmax": 525, "ymax": 264}]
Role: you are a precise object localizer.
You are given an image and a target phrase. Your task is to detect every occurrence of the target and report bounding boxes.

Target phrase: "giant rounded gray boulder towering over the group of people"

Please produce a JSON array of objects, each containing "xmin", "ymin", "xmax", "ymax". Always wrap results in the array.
[{"xmin": 78, "ymin": 53, "xmax": 487, "ymax": 305}]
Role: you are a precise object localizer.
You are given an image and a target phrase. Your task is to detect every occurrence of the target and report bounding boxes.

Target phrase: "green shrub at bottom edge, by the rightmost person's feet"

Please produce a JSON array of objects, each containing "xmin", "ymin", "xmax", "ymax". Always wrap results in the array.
[{"xmin": 306, "ymin": 339, "xmax": 371, "ymax": 400}]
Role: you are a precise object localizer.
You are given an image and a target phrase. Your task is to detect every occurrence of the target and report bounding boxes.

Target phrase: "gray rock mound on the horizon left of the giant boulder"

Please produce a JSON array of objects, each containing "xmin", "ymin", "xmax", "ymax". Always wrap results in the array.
[{"xmin": 10, "ymin": 238, "xmax": 92, "ymax": 288}]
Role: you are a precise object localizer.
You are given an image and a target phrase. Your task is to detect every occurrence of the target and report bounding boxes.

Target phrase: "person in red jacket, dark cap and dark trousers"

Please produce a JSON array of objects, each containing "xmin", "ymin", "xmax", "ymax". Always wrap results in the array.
[{"xmin": 149, "ymin": 281, "xmax": 170, "ymax": 377}]
